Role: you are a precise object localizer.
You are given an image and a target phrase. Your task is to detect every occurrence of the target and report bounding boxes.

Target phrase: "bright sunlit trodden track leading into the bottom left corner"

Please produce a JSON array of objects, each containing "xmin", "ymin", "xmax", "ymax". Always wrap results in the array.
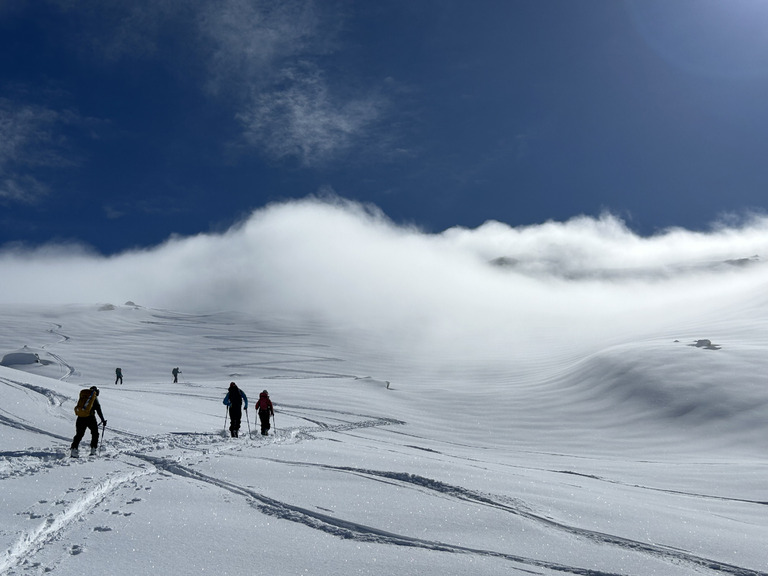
[{"xmin": 0, "ymin": 470, "xmax": 149, "ymax": 574}]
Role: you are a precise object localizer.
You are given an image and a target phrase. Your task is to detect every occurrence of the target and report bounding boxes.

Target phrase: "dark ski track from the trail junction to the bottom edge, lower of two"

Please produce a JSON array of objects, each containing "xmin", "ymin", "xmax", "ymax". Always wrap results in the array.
[{"xmin": 129, "ymin": 453, "xmax": 624, "ymax": 576}]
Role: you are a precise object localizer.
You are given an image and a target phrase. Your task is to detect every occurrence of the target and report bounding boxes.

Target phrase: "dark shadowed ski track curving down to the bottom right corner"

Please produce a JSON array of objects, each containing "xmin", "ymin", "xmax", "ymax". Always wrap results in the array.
[{"xmin": 268, "ymin": 458, "xmax": 768, "ymax": 576}]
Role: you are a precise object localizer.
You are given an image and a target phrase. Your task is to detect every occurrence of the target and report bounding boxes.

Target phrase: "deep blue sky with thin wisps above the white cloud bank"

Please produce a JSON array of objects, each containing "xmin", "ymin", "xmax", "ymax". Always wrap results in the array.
[{"xmin": 0, "ymin": 0, "xmax": 768, "ymax": 254}]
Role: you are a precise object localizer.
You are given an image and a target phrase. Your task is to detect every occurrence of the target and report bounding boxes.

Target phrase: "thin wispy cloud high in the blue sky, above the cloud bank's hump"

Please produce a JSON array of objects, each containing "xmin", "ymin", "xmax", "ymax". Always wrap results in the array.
[{"xmin": 200, "ymin": 0, "xmax": 386, "ymax": 166}]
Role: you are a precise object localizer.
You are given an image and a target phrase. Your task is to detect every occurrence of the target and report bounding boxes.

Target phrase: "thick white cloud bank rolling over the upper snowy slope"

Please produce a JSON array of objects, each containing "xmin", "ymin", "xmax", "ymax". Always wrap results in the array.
[{"xmin": 0, "ymin": 200, "xmax": 768, "ymax": 374}]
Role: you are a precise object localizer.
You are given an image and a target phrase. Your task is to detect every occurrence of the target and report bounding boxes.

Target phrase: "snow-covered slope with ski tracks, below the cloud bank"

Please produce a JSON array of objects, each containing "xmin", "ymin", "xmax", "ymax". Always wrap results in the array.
[{"xmin": 0, "ymin": 302, "xmax": 768, "ymax": 576}]
